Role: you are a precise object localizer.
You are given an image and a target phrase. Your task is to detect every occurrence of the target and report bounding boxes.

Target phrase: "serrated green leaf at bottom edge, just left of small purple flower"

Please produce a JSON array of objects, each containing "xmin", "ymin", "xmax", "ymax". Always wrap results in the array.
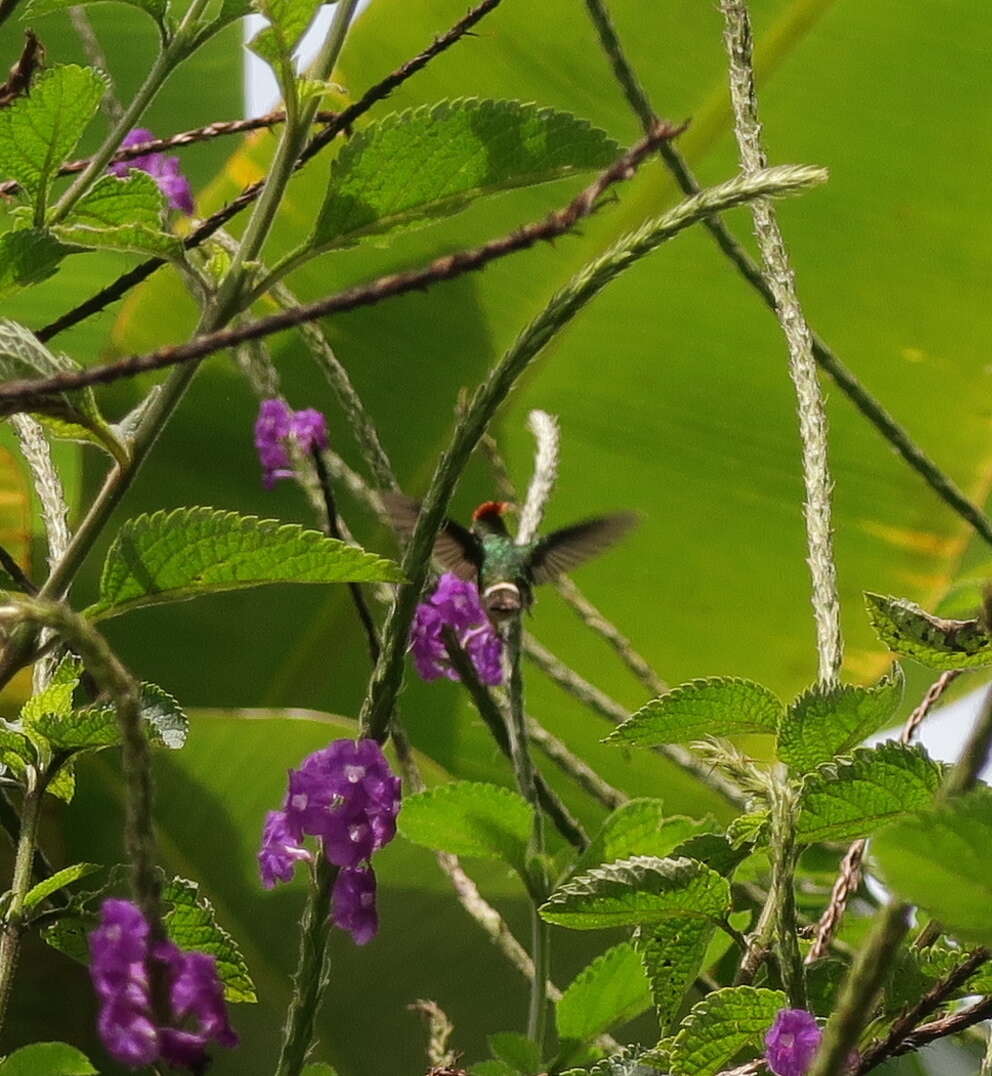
[{"xmin": 669, "ymin": 987, "xmax": 789, "ymax": 1076}]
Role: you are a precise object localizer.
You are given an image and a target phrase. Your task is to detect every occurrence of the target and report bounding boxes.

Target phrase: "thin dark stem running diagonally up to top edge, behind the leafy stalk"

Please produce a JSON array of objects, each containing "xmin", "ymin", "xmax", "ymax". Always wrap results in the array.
[{"xmin": 38, "ymin": 0, "xmax": 500, "ymax": 341}]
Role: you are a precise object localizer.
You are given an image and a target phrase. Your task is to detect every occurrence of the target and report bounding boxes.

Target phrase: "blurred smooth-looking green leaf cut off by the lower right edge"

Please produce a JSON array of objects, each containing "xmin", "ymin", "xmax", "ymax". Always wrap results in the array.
[{"xmin": 871, "ymin": 787, "xmax": 992, "ymax": 945}]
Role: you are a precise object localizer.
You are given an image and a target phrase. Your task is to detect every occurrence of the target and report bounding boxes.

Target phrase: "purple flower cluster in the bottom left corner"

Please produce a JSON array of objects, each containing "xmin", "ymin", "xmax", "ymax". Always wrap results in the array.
[{"xmin": 89, "ymin": 900, "xmax": 238, "ymax": 1068}]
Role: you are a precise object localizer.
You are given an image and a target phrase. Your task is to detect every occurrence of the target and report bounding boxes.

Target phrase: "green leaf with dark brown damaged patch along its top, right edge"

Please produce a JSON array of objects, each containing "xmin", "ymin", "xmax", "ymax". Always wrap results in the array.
[{"xmin": 865, "ymin": 592, "xmax": 992, "ymax": 670}]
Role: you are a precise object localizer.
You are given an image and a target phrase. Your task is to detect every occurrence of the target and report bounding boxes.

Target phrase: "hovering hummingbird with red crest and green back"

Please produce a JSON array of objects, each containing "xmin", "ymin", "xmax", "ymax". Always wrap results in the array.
[{"xmin": 383, "ymin": 493, "xmax": 637, "ymax": 623}]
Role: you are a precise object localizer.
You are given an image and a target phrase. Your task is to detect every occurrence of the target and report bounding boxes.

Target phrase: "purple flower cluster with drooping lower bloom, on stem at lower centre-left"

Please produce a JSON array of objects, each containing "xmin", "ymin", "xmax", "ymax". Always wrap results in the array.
[{"xmin": 258, "ymin": 739, "xmax": 400, "ymax": 945}]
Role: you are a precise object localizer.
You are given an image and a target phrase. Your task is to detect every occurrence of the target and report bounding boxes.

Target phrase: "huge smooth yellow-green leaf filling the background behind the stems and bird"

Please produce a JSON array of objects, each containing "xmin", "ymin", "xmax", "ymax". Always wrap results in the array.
[{"xmin": 3, "ymin": 0, "xmax": 992, "ymax": 1076}]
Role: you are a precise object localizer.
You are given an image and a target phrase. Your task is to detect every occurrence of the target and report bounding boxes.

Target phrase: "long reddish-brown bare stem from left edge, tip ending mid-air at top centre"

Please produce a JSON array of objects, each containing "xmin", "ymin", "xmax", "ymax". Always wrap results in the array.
[{"xmin": 0, "ymin": 126, "xmax": 682, "ymax": 406}]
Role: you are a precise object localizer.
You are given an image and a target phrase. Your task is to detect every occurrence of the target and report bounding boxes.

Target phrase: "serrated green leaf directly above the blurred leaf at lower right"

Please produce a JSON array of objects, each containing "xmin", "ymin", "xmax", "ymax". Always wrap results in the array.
[{"xmin": 796, "ymin": 740, "xmax": 943, "ymax": 844}]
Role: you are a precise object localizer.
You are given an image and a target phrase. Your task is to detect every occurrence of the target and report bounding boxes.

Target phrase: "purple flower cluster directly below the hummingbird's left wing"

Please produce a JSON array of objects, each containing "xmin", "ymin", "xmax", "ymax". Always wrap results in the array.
[{"xmin": 410, "ymin": 571, "xmax": 502, "ymax": 685}]
